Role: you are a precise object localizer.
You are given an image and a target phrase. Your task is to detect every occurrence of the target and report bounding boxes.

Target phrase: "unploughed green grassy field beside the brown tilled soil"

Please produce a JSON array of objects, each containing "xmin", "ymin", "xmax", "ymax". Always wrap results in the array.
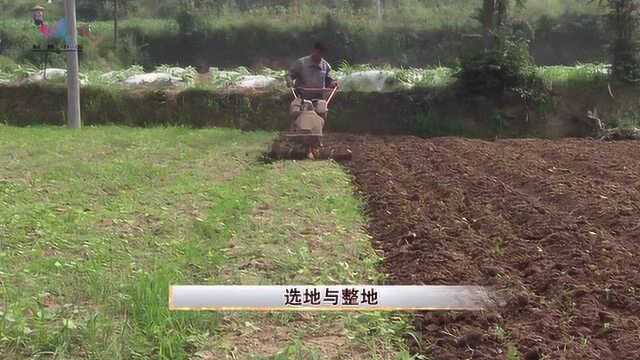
[{"xmin": 0, "ymin": 126, "xmax": 418, "ymax": 359}]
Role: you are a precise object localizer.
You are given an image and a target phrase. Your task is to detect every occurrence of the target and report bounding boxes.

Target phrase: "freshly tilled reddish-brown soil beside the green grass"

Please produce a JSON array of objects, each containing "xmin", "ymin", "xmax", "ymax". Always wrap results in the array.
[{"xmin": 325, "ymin": 136, "xmax": 640, "ymax": 360}]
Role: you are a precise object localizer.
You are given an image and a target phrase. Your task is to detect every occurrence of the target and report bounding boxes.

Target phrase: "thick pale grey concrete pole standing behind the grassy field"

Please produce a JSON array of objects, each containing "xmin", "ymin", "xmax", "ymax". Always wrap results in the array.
[{"xmin": 64, "ymin": 0, "xmax": 82, "ymax": 129}]
